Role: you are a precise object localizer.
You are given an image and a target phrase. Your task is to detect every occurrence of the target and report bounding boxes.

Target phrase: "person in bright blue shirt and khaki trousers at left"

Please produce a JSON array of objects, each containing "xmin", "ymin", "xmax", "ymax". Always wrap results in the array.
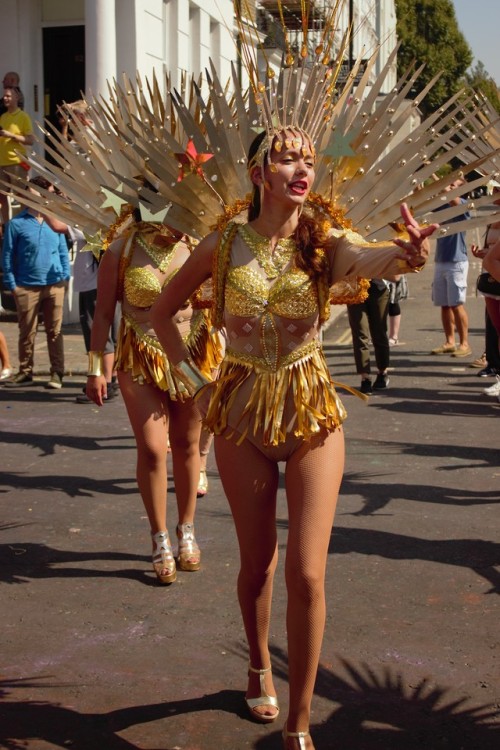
[{"xmin": 3, "ymin": 177, "xmax": 70, "ymax": 389}]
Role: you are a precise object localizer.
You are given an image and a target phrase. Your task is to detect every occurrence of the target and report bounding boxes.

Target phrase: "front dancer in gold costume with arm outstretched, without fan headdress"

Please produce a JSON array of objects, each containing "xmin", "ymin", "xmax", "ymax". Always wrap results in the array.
[{"xmin": 151, "ymin": 129, "xmax": 436, "ymax": 750}]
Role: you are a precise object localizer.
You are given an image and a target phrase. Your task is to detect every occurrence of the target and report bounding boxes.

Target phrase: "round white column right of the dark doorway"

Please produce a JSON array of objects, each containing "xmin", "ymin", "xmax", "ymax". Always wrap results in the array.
[{"xmin": 85, "ymin": 0, "xmax": 116, "ymax": 96}]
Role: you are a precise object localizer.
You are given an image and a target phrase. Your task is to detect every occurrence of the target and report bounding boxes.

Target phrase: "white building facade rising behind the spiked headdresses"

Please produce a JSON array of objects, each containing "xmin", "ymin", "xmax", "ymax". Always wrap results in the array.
[{"xmin": 0, "ymin": 0, "xmax": 396, "ymax": 138}]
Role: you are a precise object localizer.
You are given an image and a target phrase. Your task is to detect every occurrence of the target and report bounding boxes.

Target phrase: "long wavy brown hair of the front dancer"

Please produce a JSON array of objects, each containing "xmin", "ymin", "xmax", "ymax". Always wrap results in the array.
[{"xmin": 247, "ymin": 131, "xmax": 327, "ymax": 278}]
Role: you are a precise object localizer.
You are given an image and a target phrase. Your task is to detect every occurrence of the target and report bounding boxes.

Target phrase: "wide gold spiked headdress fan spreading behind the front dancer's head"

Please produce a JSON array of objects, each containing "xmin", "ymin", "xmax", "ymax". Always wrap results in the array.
[{"xmin": 7, "ymin": 0, "xmax": 500, "ymax": 248}]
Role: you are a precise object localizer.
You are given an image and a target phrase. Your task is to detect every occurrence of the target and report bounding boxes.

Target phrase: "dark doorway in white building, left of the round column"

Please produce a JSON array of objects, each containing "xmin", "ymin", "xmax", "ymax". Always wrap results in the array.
[{"xmin": 43, "ymin": 26, "xmax": 85, "ymax": 147}]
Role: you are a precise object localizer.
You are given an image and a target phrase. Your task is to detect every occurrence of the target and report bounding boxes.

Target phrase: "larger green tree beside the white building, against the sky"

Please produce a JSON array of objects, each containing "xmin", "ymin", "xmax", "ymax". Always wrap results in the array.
[{"xmin": 396, "ymin": 0, "xmax": 473, "ymax": 115}]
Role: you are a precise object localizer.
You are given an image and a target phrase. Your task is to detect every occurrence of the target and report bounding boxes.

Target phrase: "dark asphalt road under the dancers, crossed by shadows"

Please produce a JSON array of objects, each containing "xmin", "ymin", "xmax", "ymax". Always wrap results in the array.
[{"xmin": 0, "ymin": 256, "xmax": 500, "ymax": 750}]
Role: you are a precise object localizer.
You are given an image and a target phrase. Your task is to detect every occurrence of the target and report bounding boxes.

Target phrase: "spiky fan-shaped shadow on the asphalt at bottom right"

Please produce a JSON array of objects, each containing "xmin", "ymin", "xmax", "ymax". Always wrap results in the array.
[{"xmin": 255, "ymin": 653, "xmax": 500, "ymax": 750}]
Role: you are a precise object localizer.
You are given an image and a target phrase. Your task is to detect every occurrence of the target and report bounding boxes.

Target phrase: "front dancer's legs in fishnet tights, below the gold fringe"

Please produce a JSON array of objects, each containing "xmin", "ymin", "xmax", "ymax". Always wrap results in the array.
[{"xmin": 215, "ymin": 430, "xmax": 344, "ymax": 731}]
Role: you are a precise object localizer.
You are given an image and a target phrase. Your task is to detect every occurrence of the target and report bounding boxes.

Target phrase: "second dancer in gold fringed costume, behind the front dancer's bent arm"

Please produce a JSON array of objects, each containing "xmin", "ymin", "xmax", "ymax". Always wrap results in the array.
[{"xmin": 86, "ymin": 209, "xmax": 217, "ymax": 584}]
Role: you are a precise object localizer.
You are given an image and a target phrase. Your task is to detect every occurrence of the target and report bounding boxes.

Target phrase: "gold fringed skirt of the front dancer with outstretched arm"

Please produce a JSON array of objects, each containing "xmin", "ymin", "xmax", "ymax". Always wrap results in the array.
[{"xmin": 204, "ymin": 341, "xmax": 350, "ymax": 446}]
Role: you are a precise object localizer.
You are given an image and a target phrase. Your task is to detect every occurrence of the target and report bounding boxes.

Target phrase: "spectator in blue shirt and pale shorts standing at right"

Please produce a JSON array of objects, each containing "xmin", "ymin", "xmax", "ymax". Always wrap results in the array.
[{"xmin": 431, "ymin": 179, "xmax": 472, "ymax": 357}]
